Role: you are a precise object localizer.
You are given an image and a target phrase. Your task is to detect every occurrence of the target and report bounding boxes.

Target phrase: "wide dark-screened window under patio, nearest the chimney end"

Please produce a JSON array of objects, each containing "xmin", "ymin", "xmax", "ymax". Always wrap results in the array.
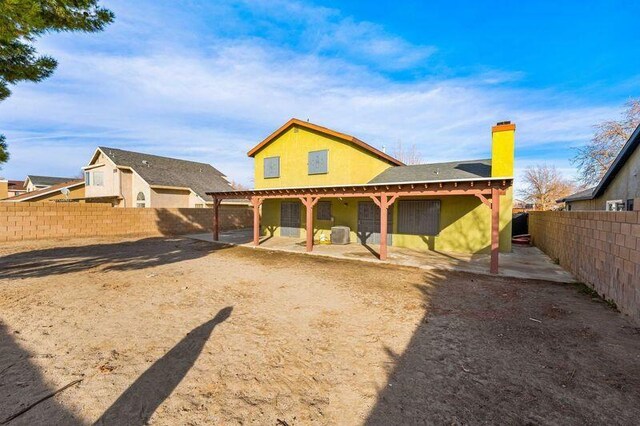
[{"xmin": 398, "ymin": 200, "xmax": 440, "ymax": 235}]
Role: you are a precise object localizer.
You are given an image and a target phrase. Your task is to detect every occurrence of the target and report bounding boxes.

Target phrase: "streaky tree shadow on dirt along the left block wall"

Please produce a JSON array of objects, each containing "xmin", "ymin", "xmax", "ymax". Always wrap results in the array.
[{"xmin": 0, "ymin": 238, "xmax": 232, "ymax": 279}]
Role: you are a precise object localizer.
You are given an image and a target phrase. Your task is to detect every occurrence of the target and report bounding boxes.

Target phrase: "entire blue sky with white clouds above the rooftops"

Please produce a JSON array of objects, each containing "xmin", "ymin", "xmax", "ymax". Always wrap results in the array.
[{"xmin": 0, "ymin": 0, "xmax": 640, "ymax": 191}]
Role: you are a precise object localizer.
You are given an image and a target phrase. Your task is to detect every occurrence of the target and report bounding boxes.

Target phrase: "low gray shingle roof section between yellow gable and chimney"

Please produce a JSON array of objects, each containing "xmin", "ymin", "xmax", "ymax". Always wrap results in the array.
[{"xmin": 369, "ymin": 159, "xmax": 491, "ymax": 183}]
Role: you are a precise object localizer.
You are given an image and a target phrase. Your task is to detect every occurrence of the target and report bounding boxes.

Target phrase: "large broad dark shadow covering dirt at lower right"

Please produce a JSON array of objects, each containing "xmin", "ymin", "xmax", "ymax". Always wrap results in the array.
[{"xmin": 365, "ymin": 272, "xmax": 640, "ymax": 425}]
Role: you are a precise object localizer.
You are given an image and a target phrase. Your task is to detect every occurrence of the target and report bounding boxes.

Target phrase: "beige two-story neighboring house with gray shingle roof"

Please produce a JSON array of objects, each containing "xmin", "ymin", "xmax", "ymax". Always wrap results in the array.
[{"xmin": 83, "ymin": 147, "xmax": 238, "ymax": 207}]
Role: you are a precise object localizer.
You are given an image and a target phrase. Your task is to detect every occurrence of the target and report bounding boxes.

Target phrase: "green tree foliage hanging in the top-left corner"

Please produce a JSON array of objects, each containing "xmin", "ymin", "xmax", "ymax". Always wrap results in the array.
[{"xmin": 0, "ymin": 0, "xmax": 114, "ymax": 164}]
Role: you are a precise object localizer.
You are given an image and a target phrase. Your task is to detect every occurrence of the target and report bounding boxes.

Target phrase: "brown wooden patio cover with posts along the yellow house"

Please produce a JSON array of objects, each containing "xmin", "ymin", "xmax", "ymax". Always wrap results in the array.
[{"xmin": 207, "ymin": 178, "xmax": 512, "ymax": 274}]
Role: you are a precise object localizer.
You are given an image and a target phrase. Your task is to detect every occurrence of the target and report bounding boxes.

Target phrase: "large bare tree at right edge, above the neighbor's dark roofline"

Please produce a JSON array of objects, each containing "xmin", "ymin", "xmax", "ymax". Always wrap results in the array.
[{"xmin": 571, "ymin": 99, "xmax": 640, "ymax": 186}]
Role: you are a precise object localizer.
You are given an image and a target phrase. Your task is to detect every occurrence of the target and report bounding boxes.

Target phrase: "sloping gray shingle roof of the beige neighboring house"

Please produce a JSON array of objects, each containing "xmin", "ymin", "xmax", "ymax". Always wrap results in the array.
[{"xmin": 99, "ymin": 146, "xmax": 232, "ymax": 201}]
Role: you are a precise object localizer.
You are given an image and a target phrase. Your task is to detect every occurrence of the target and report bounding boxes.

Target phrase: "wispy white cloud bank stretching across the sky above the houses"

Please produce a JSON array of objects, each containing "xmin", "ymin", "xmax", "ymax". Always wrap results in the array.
[{"xmin": 0, "ymin": 3, "xmax": 616, "ymax": 187}]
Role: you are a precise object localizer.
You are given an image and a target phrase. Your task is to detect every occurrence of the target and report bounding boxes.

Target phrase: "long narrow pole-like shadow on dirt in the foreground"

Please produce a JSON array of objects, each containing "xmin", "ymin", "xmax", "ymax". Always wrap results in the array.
[{"xmin": 95, "ymin": 306, "xmax": 233, "ymax": 425}]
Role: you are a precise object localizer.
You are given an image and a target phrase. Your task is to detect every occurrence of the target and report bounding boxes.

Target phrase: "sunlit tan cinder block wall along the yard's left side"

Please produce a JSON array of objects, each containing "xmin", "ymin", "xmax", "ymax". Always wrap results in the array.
[{"xmin": 0, "ymin": 202, "xmax": 253, "ymax": 242}]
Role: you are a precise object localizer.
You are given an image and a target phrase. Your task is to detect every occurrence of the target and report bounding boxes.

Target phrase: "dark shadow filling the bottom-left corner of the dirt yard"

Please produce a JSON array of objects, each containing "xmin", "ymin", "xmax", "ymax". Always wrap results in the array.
[{"xmin": 0, "ymin": 322, "xmax": 82, "ymax": 425}]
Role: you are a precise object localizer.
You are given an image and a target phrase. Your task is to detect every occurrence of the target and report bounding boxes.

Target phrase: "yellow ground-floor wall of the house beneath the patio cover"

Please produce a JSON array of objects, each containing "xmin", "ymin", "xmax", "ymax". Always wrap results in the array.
[{"xmin": 261, "ymin": 189, "xmax": 511, "ymax": 253}]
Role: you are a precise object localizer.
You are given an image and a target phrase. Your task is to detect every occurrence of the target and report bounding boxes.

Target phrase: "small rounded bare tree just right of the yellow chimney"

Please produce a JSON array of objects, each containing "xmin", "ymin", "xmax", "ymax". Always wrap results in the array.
[{"xmin": 519, "ymin": 164, "xmax": 576, "ymax": 210}]
